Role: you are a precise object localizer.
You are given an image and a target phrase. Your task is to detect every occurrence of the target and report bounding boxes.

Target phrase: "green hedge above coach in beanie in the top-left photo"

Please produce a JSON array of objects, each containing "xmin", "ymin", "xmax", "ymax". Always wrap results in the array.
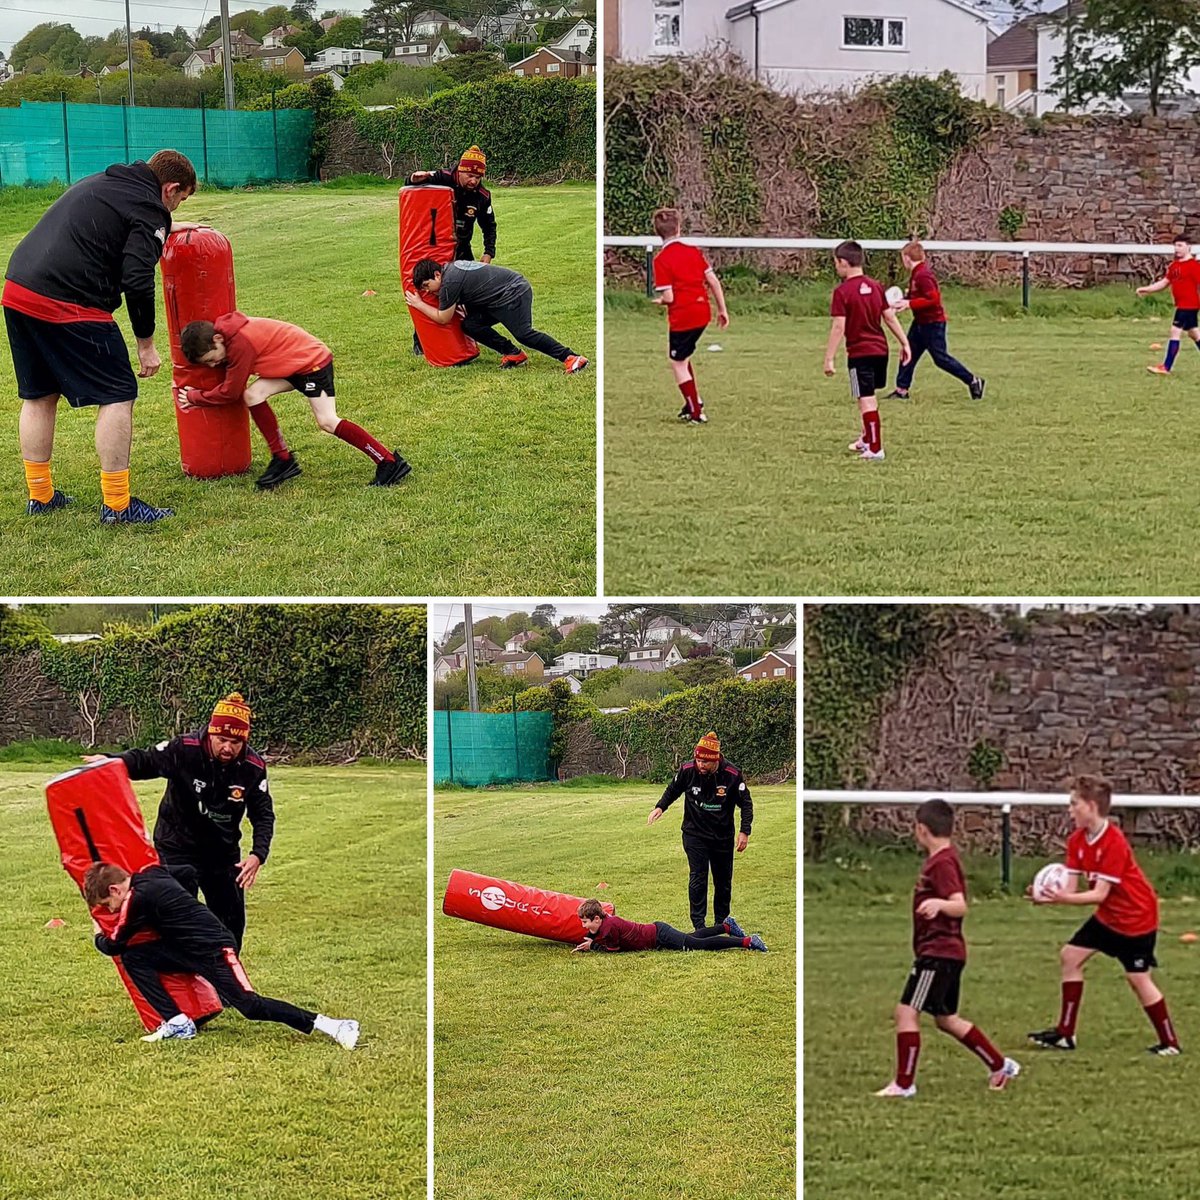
[{"xmin": 353, "ymin": 76, "xmax": 596, "ymax": 181}]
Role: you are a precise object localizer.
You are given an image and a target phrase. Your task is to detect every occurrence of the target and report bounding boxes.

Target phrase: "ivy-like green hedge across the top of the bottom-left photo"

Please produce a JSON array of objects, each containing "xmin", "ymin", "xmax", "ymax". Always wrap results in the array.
[{"xmin": 0, "ymin": 604, "xmax": 426, "ymax": 757}]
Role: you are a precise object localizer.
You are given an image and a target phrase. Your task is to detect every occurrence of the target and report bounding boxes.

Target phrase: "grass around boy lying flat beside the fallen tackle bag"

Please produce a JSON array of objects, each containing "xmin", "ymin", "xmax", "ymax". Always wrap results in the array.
[{"xmin": 433, "ymin": 780, "xmax": 796, "ymax": 1200}]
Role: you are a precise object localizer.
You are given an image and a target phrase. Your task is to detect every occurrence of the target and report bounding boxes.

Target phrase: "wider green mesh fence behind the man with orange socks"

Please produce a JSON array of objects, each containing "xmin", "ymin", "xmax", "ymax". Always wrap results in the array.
[{"xmin": 0, "ymin": 100, "xmax": 312, "ymax": 187}]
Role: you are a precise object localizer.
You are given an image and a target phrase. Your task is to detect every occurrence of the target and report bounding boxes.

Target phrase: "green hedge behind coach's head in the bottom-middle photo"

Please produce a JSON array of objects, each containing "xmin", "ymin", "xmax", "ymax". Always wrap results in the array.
[{"xmin": 592, "ymin": 679, "xmax": 796, "ymax": 780}]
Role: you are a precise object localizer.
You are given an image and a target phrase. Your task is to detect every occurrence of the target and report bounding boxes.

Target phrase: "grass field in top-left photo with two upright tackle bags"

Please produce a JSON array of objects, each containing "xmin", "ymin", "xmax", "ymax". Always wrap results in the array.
[{"xmin": 0, "ymin": 185, "xmax": 596, "ymax": 596}]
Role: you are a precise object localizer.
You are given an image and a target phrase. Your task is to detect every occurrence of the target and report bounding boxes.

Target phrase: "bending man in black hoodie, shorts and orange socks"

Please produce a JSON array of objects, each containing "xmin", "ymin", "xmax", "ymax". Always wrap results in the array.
[{"xmin": 0, "ymin": 150, "xmax": 196, "ymax": 523}]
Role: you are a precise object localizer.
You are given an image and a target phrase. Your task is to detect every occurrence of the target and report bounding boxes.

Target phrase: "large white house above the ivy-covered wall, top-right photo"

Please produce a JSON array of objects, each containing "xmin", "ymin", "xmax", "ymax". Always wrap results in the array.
[{"xmin": 605, "ymin": 0, "xmax": 990, "ymax": 100}]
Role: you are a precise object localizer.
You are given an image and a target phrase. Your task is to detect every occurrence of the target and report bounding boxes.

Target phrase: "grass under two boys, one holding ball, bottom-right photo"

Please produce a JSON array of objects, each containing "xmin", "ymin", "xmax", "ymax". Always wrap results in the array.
[{"xmin": 803, "ymin": 850, "xmax": 1200, "ymax": 1200}]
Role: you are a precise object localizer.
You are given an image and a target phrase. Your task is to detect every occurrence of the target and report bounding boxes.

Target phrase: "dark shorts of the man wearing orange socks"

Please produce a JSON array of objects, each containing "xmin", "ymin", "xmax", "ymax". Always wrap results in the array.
[{"xmin": 4, "ymin": 307, "xmax": 138, "ymax": 408}]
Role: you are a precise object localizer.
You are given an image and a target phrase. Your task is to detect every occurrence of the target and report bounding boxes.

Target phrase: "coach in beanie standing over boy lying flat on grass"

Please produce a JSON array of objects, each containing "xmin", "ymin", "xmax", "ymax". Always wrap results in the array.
[{"xmin": 646, "ymin": 733, "xmax": 754, "ymax": 929}]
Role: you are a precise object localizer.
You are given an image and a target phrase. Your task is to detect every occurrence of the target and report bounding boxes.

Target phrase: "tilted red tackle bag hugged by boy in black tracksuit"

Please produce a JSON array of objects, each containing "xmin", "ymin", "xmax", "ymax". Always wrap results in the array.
[{"xmin": 46, "ymin": 758, "xmax": 221, "ymax": 1030}]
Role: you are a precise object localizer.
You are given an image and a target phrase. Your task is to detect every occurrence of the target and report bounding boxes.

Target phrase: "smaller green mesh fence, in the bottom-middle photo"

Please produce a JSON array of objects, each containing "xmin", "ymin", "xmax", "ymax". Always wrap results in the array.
[{"xmin": 433, "ymin": 709, "xmax": 552, "ymax": 787}]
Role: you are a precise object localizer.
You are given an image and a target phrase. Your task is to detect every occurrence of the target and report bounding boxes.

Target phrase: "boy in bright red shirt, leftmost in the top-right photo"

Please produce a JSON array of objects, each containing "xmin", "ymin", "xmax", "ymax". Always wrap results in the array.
[{"xmin": 654, "ymin": 209, "xmax": 730, "ymax": 424}]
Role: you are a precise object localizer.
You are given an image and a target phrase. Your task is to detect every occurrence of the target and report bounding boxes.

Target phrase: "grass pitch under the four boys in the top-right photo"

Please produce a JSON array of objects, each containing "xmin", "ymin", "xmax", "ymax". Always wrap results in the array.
[{"xmin": 605, "ymin": 284, "xmax": 1200, "ymax": 595}]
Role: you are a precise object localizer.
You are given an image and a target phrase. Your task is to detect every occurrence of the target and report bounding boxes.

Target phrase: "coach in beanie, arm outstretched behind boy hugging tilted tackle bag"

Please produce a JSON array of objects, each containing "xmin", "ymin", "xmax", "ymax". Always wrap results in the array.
[{"xmin": 89, "ymin": 692, "xmax": 275, "ymax": 950}]
